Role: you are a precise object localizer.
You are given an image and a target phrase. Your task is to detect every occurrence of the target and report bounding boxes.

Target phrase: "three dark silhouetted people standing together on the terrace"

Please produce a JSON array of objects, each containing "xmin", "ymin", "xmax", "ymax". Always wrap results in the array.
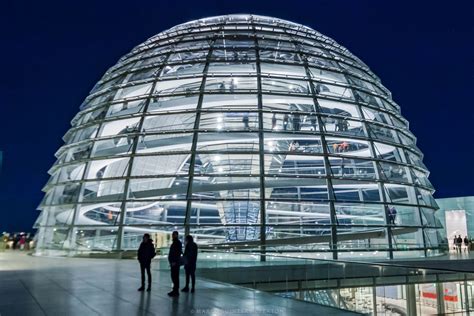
[{"xmin": 138, "ymin": 231, "xmax": 198, "ymax": 297}]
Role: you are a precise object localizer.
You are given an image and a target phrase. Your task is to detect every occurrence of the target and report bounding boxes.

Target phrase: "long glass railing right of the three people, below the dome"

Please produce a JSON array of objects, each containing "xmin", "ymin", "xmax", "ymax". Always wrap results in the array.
[{"xmin": 182, "ymin": 249, "xmax": 474, "ymax": 315}]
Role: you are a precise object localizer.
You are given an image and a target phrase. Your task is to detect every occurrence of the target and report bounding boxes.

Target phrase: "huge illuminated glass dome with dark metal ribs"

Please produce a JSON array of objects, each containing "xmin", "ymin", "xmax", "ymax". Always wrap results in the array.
[{"xmin": 35, "ymin": 15, "xmax": 440, "ymax": 258}]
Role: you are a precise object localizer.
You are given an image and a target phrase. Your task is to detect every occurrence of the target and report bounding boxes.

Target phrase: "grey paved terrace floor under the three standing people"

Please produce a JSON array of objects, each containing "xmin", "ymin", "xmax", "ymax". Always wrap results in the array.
[{"xmin": 0, "ymin": 251, "xmax": 355, "ymax": 316}]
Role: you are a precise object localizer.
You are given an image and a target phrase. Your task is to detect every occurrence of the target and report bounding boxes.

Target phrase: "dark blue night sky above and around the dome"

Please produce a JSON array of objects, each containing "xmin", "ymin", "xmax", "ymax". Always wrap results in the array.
[{"xmin": 0, "ymin": 0, "xmax": 474, "ymax": 233}]
